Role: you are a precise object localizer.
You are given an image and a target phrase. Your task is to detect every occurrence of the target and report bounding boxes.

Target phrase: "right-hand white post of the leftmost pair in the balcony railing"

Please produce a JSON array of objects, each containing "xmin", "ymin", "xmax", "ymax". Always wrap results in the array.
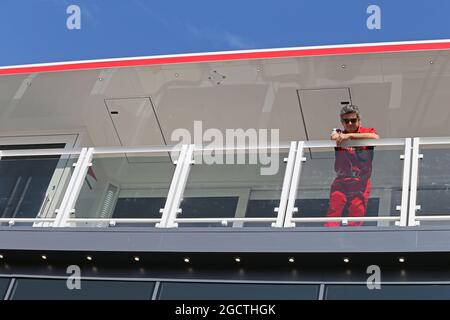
[{"xmin": 55, "ymin": 148, "xmax": 94, "ymax": 227}]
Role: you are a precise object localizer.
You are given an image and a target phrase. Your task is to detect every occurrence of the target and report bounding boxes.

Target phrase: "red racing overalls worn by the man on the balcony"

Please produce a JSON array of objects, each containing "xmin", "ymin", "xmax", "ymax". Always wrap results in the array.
[{"xmin": 325, "ymin": 127, "xmax": 377, "ymax": 227}]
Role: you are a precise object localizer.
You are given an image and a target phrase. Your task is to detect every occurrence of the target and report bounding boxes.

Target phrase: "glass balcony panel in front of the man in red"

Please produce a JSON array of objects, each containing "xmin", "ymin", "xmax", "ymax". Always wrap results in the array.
[{"xmin": 293, "ymin": 146, "xmax": 404, "ymax": 227}]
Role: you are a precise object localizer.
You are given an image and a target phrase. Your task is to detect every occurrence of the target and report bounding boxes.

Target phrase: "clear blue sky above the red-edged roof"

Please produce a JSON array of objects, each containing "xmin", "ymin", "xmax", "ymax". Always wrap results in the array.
[{"xmin": 0, "ymin": 0, "xmax": 450, "ymax": 66}]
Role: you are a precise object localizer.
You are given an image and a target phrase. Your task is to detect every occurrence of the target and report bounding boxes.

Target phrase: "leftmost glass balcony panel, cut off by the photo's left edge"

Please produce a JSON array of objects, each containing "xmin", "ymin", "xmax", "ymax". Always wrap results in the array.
[{"xmin": 0, "ymin": 155, "xmax": 78, "ymax": 227}]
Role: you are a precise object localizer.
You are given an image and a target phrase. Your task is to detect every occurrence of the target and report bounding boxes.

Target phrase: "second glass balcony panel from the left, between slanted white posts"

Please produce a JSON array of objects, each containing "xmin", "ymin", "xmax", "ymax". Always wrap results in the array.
[{"xmin": 71, "ymin": 152, "xmax": 178, "ymax": 227}]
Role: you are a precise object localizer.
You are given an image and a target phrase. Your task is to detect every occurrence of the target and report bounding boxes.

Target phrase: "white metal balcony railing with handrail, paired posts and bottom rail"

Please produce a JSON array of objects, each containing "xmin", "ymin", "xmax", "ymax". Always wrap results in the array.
[{"xmin": 0, "ymin": 138, "xmax": 450, "ymax": 228}]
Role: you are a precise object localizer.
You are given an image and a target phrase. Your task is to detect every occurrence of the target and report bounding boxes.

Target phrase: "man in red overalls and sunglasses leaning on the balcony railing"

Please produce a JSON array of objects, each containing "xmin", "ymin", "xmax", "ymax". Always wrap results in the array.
[{"xmin": 325, "ymin": 105, "xmax": 379, "ymax": 227}]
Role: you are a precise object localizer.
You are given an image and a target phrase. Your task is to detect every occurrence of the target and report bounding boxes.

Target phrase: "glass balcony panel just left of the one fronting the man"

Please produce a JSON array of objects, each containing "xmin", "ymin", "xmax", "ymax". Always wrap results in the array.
[{"xmin": 177, "ymin": 148, "xmax": 289, "ymax": 227}]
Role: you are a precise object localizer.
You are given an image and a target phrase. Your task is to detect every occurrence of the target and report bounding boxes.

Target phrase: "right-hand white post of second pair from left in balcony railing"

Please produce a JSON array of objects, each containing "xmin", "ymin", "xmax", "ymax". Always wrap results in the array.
[{"xmin": 166, "ymin": 144, "xmax": 195, "ymax": 228}]
